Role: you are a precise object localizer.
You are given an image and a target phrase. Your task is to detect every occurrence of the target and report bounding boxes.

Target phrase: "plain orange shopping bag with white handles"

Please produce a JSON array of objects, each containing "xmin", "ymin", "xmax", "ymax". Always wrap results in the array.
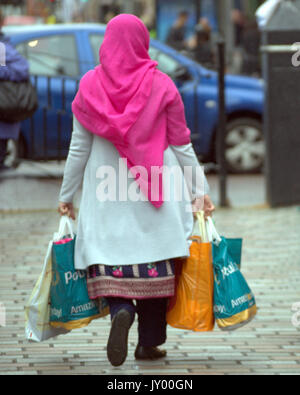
[{"xmin": 167, "ymin": 212, "xmax": 215, "ymax": 332}]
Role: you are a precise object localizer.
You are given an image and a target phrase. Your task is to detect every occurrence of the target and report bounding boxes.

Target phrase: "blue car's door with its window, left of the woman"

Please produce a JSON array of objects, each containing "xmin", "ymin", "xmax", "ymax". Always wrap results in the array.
[{"xmin": 16, "ymin": 32, "xmax": 81, "ymax": 160}]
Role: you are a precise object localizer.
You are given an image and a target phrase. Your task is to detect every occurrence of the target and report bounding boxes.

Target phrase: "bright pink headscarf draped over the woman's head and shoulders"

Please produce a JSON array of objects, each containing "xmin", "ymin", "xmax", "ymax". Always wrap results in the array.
[{"xmin": 72, "ymin": 14, "xmax": 190, "ymax": 207}]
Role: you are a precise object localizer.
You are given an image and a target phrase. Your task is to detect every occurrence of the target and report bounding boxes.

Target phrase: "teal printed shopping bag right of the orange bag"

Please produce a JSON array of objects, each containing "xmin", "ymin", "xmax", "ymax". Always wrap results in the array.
[{"xmin": 207, "ymin": 218, "xmax": 257, "ymax": 331}]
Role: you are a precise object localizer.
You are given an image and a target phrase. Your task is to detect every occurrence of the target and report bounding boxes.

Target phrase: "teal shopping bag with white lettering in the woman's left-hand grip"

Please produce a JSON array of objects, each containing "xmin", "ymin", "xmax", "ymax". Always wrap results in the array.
[{"xmin": 50, "ymin": 216, "xmax": 109, "ymax": 330}]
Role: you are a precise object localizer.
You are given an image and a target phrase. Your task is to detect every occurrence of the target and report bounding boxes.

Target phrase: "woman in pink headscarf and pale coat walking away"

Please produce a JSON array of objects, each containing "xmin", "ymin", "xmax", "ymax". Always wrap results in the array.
[{"xmin": 58, "ymin": 14, "xmax": 214, "ymax": 366}]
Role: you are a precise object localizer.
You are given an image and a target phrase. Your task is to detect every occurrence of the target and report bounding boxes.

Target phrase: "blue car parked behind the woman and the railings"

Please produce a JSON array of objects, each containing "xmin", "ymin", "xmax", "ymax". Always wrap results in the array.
[{"xmin": 4, "ymin": 24, "xmax": 265, "ymax": 173}]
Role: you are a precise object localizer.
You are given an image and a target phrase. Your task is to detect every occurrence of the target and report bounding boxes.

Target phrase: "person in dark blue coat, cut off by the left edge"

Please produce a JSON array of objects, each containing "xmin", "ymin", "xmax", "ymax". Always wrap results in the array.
[{"xmin": 0, "ymin": 10, "xmax": 29, "ymax": 171}]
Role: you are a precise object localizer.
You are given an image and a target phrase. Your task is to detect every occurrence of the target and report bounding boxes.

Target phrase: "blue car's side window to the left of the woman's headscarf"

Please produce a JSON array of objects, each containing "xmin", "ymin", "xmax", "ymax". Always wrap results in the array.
[{"xmin": 17, "ymin": 34, "xmax": 79, "ymax": 77}]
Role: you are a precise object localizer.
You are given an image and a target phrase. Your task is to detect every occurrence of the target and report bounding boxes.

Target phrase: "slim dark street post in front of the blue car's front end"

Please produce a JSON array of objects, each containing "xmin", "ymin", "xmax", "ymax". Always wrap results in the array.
[{"xmin": 217, "ymin": 38, "xmax": 228, "ymax": 207}]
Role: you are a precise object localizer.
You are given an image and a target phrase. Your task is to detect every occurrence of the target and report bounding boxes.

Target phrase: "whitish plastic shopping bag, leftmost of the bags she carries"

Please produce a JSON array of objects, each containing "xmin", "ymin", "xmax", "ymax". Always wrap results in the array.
[{"xmin": 25, "ymin": 240, "xmax": 69, "ymax": 342}]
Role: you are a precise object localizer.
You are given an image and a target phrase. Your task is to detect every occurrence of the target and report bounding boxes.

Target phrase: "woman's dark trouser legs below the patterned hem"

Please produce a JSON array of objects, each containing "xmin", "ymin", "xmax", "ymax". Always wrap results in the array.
[{"xmin": 106, "ymin": 297, "xmax": 168, "ymax": 347}]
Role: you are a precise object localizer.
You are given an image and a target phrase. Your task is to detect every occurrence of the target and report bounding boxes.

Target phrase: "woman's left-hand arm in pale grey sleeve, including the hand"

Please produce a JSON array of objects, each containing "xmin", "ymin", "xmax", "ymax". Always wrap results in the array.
[{"xmin": 58, "ymin": 117, "xmax": 93, "ymax": 219}]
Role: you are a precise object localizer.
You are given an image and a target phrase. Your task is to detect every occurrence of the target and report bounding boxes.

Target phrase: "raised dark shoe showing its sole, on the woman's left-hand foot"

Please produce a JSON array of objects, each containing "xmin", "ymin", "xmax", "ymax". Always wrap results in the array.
[{"xmin": 107, "ymin": 309, "xmax": 133, "ymax": 366}]
